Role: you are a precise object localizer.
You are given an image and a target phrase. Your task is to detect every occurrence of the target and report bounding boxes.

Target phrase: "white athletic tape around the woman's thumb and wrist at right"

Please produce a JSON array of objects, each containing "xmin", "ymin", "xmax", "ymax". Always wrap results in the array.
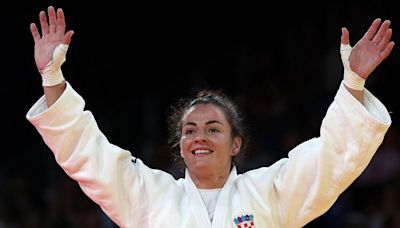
[{"xmin": 340, "ymin": 44, "xmax": 365, "ymax": 91}]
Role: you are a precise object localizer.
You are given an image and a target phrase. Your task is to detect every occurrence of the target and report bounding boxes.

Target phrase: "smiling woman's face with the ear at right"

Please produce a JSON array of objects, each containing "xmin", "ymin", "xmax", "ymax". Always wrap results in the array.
[{"xmin": 180, "ymin": 104, "xmax": 241, "ymax": 175}]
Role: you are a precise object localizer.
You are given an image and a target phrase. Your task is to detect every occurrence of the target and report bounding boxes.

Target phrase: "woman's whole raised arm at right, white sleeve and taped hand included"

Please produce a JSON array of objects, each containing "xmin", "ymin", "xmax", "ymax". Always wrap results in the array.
[{"xmin": 248, "ymin": 19, "xmax": 394, "ymax": 227}]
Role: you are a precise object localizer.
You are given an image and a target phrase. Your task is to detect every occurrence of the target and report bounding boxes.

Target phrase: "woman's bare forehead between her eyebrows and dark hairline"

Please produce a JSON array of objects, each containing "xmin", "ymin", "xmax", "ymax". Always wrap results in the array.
[{"xmin": 182, "ymin": 104, "xmax": 226, "ymax": 123}]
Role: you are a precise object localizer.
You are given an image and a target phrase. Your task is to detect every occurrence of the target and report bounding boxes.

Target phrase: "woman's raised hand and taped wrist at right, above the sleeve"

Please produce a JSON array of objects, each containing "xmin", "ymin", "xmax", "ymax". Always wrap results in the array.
[{"xmin": 341, "ymin": 18, "xmax": 394, "ymax": 102}]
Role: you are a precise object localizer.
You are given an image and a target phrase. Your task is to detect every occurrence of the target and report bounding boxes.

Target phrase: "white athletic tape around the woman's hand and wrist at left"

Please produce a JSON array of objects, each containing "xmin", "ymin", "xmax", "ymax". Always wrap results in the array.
[{"xmin": 40, "ymin": 44, "xmax": 69, "ymax": 86}]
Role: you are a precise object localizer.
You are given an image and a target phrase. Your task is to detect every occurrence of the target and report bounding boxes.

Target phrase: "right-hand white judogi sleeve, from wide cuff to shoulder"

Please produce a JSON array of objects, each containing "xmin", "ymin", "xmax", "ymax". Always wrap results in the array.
[{"xmin": 244, "ymin": 83, "xmax": 391, "ymax": 227}]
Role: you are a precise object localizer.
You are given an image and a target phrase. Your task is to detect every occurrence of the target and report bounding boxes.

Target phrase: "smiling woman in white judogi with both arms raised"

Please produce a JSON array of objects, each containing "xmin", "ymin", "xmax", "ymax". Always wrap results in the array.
[{"xmin": 27, "ymin": 6, "xmax": 394, "ymax": 228}]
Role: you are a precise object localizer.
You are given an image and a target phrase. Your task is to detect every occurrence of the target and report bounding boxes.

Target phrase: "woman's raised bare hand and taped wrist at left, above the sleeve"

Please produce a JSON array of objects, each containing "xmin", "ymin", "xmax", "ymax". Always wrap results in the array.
[{"xmin": 30, "ymin": 6, "xmax": 74, "ymax": 107}]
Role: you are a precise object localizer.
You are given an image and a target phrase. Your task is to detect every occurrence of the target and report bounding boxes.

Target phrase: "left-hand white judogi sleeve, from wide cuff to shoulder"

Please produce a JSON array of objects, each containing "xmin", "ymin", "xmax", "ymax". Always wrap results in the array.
[{"xmin": 26, "ymin": 83, "xmax": 172, "ymax": 227}]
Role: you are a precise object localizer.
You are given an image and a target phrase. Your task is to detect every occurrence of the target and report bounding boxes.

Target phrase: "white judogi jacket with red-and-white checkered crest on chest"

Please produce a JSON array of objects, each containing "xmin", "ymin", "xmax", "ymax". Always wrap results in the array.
[{"xmin": 27, "ymin": 83, "xmax": 391, "ymax": 228}]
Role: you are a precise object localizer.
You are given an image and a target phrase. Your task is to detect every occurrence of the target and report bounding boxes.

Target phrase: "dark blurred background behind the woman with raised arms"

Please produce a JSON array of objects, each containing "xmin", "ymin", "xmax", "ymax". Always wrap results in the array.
[{"xmin": 0, "ymin": 0, "xmax": 400, "ymax": 228}]
